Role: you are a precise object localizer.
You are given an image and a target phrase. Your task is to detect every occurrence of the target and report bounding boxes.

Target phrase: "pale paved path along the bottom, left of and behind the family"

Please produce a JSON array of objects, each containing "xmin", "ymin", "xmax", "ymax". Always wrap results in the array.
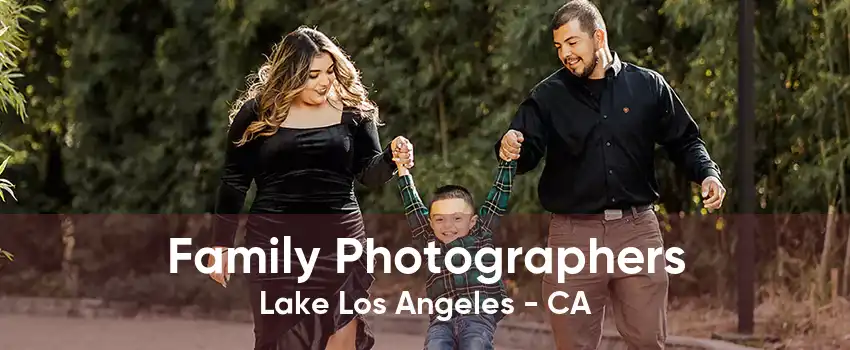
[{"xmin": 0, "ymin": 315, "xmax": 511, "ymax": 350}]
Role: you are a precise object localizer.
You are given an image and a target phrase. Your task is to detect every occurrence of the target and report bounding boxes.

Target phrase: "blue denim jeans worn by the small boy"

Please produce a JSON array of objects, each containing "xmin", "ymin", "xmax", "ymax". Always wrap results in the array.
[{"xmin": 425, "ymin": 314, "xmax": 496, "ymax": 350}]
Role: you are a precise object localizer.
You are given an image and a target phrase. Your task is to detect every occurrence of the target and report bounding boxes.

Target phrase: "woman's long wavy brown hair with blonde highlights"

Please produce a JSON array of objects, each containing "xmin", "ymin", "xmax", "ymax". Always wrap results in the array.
[{"xmin": 228, "ymin": 26, "xmax": 380, "ymax": 146}]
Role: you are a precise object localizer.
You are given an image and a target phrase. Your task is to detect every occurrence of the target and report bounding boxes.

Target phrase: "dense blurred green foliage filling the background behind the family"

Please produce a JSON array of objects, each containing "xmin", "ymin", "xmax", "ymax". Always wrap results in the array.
[{"xmin": 0, "ymin": 0, "xmax": 850, "ymax": 344}]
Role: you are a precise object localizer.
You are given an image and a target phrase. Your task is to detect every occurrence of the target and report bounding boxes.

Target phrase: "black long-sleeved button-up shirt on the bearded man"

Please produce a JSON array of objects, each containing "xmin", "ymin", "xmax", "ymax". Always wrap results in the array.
[{"xmin": 495, "ymin": 53, "xmax": 720, "ymax": 214}]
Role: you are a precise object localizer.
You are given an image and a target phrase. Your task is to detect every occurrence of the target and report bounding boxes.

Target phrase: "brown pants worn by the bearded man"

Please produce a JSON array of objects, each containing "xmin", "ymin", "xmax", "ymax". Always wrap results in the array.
[{"xmin": 542, "ymin": 210, "xmax": 669, "ymax": 350}]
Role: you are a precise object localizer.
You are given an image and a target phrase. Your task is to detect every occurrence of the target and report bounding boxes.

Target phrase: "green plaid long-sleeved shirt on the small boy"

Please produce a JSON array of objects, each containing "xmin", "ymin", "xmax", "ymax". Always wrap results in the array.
[{"xmin": 398, "ymin": 159, "xmax": 516, "ymax": 320}]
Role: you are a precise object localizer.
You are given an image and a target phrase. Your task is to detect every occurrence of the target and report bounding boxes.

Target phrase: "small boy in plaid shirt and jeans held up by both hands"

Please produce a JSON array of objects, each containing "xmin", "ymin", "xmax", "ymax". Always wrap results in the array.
[{"xmin": 397, "ymin": 153, "xmax": 516, "ymax": 350}]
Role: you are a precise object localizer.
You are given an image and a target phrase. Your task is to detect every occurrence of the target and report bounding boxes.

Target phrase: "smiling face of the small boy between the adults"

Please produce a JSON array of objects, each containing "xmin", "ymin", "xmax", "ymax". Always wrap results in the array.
[{"xmin": 431, "ymin": 198, "xmax": 478, "ymax": 243}]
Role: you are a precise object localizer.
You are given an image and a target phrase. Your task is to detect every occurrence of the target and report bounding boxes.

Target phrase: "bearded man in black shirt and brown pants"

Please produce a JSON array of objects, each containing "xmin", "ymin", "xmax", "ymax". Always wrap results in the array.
[{"xmin": 495, "ymin": 0, "xmax": 726, "ymax": 350}]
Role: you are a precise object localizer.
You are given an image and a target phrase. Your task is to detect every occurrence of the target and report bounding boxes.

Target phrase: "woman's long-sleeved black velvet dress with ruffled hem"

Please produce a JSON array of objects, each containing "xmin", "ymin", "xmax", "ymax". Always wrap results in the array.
[{"xmin": 213, "ymin": 100, "xmax": 395, "ymax": 350}]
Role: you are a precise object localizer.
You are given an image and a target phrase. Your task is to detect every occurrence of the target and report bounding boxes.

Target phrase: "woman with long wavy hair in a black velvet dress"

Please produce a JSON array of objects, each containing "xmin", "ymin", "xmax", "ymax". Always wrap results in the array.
[{"xmin": 209, "ymin": 27, "xmax": 413, "ymax": 350}]
